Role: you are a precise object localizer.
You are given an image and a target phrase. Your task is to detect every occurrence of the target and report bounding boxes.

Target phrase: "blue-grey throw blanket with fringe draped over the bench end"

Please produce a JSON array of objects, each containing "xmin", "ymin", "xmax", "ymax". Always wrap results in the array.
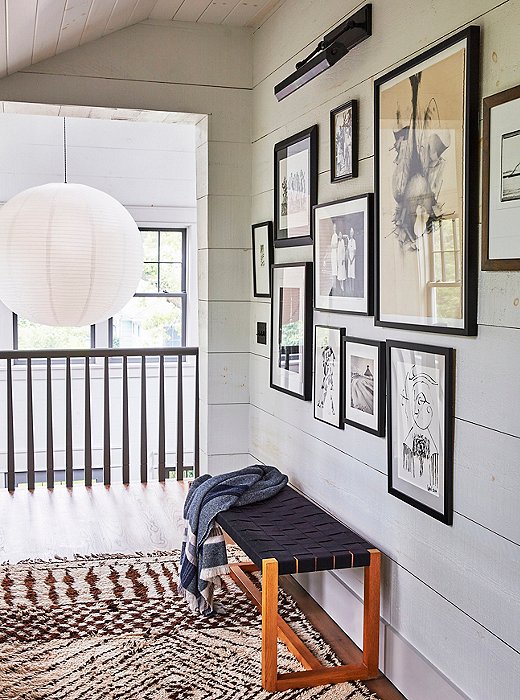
[{"xmin": 179, "ymin": 464, "xmax": 287, "ymax": 614}]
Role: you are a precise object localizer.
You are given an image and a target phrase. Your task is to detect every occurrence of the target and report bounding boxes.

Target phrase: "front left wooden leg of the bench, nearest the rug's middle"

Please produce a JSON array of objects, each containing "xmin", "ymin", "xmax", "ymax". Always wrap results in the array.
[{"xmin": 262, "ymin": 559, "xmax": 278, "ymax": 693}]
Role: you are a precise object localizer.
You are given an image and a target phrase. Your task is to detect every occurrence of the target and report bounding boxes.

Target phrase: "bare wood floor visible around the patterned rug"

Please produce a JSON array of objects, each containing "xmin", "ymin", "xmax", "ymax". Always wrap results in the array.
[{"xmin": 0, "ymin": 482, "xmax": 406, "ymax": 700}]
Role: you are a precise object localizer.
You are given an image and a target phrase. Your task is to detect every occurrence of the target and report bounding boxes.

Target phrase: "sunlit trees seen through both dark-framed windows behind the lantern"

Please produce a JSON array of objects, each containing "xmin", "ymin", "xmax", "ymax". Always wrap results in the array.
[{"xmin": 15, "ymin": 229, "xmax": 186, "ymax": 350}]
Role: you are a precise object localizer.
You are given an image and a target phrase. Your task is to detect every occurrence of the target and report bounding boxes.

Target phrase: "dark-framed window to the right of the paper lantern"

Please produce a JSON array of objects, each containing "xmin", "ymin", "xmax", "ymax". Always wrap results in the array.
[{"xmin": 109, "ymin": 228, "xmax": 186, "ymax": 348}]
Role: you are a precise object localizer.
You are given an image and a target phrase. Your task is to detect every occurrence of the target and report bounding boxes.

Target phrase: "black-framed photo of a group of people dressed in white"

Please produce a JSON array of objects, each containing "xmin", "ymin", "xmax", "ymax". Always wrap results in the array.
[{"xmin": 314, "ymin": 194, "xmax": 373, "ymax": 316}]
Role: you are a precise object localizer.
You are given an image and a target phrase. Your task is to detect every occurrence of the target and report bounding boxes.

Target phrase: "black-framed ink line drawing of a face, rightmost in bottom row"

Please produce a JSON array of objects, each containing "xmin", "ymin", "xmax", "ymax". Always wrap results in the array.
[{"xmin": 386, "ymin": 340, "xmax": 454, "ymax": 525}]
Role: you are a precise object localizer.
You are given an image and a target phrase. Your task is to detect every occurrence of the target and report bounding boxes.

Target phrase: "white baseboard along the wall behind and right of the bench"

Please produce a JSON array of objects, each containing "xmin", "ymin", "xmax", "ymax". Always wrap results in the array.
[{"xmin": 294, "ymin": 571, "xmax": 471, "ymax": 700}]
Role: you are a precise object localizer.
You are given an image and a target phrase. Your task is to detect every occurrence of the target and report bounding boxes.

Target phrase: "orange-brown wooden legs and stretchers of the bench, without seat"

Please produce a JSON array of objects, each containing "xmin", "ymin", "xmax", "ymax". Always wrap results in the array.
[{"xmin": 230, "ymin": 549, "xmax": 381, "ymax": 692}]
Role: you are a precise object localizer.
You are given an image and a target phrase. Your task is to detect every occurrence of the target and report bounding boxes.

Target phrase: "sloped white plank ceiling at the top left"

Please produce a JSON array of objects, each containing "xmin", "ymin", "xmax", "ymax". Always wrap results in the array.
[{"xmin": 0, "ymin": 0, "xmax": 283, "ymax": 77}]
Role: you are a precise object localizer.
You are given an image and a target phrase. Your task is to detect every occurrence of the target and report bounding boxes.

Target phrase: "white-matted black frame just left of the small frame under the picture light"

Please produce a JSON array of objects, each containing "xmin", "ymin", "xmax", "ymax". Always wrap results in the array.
[{"xmin": 274, "ymin": 125, "xmax": 318, "ymax": 247}]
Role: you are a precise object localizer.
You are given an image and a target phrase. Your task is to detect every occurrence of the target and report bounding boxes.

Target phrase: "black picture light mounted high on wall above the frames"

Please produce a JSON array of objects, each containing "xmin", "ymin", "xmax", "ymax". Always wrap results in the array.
[{"xmin": 274, "ymin": 3, "xmax": 372, "ymax": 102}]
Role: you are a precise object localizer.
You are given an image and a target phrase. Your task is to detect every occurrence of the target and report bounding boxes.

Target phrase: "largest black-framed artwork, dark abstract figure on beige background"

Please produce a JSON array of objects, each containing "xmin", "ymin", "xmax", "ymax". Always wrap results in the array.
[{"xmin": 374, "ymin": 27, "xmax": 479, "ymax": 335}]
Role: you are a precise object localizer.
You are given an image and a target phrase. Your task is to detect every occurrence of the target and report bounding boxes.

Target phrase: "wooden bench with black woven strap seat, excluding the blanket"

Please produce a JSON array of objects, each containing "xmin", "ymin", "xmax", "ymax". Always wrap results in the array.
[{"xmin": 217, "ymin": 486, "xmax": 381, "ymax": 692}]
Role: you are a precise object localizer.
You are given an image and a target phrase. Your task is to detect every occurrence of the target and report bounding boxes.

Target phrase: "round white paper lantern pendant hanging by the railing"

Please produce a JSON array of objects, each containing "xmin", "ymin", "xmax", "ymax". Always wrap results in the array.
[{"xmin": 0, "ymin": 121, "xmax": 143, "ymax": 326}]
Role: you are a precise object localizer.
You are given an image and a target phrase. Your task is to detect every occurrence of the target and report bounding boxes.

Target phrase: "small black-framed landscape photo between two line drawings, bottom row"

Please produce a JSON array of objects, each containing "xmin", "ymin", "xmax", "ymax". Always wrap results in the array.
[{"xmin": 343, "ymin": 336, "xmax": 386, "ymax": 437}]
